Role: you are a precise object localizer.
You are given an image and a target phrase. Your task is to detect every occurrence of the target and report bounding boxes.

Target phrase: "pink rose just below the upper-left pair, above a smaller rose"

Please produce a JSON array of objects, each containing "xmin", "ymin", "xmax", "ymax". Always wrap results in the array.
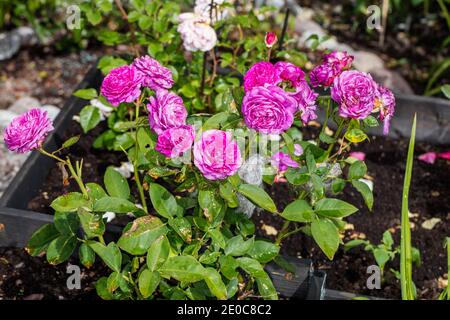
[{"xmin": 147, "ymin": 90, "xmax": 187, "ymax": 134}]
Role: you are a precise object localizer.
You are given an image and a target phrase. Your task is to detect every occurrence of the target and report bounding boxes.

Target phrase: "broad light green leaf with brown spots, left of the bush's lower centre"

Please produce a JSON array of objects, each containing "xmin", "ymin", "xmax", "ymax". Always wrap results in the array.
[{"xmin": 117, "ymin": 215, "xmax": 167, "ymax": 255}]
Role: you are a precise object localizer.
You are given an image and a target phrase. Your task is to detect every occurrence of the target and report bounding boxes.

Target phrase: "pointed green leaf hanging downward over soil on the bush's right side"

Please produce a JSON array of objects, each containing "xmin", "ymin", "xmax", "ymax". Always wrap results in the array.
[{"xmin": 311, "ymin": 219, "xmax": 339, "ymax": 260}]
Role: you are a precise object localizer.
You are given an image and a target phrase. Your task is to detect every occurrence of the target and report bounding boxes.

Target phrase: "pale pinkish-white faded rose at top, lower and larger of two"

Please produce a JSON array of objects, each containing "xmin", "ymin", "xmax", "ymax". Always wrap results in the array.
[{"xmin": 177, "ymin": 13, "xmax": 217, "ymax": 52}]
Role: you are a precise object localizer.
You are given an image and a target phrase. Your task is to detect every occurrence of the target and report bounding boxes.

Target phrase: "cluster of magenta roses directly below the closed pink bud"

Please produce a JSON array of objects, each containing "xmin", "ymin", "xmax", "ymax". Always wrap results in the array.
[{"xmin": 242, "ymin": 61, "xmax": 318, "ymax": 134}]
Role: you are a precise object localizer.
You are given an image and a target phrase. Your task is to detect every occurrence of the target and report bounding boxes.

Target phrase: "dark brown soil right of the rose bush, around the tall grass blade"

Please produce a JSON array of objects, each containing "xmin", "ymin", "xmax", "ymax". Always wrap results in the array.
[{"xmin": 254, "ymin": 132, "xmax": 450, "ymax": 299}]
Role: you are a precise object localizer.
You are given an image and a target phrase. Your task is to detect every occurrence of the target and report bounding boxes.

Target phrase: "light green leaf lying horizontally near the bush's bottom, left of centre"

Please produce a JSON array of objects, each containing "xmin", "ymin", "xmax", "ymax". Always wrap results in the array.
[{"xmin": 159, "ymin": 256, "xmax": 205, "ymax": 283}]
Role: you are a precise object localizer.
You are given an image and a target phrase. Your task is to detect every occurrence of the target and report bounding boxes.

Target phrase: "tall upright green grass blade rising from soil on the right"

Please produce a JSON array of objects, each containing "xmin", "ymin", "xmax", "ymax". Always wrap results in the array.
[{"xmin": 400, "ymin": 115, "xmax": 417, "ymax": 300}]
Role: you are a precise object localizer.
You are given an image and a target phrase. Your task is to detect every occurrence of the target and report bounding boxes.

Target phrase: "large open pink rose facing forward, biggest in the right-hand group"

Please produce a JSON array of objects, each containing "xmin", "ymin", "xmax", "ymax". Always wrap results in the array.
[{"xmin": 331, "ymin": 70, "xmax": 378, "ymax": 119}]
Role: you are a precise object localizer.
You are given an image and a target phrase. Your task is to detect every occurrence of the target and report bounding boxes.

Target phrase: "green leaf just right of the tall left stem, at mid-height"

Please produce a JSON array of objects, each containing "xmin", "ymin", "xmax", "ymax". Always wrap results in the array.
[{"xmin": 150, "ymin": 183, "xmax": 183, "ymax": 219}]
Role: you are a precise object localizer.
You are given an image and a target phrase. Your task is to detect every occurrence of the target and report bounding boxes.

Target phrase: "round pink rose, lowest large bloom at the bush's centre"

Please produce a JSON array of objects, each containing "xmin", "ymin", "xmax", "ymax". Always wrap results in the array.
[{"xmin": 194, "ymin": 130, "xmax": 242, "ymax": 180}]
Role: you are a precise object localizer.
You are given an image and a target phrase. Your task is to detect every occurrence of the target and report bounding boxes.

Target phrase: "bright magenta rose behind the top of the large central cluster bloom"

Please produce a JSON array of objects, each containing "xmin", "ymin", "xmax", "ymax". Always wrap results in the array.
[{"xmin": 244, "ymin": 61, "xmax": 281, "ymax": 92}]
